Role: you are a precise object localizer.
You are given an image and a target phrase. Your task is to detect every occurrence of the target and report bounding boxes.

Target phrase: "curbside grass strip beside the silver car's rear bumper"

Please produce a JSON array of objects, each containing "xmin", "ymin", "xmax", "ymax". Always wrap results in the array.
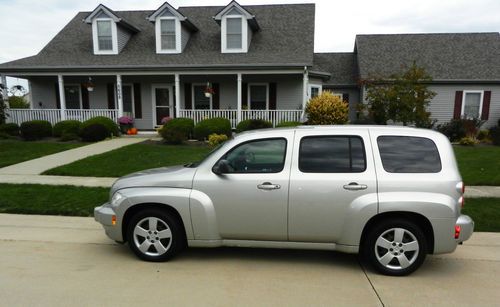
[{"xmin": 462, "ymin": 198, "xmax": 500, "ymax": 232}]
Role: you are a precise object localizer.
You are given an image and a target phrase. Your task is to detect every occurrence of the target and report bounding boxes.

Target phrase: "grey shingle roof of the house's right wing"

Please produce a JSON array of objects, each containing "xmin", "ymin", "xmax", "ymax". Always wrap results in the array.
[{"xmin": 355, "ymin": 33, "xmax": 500, "ymax": 81}]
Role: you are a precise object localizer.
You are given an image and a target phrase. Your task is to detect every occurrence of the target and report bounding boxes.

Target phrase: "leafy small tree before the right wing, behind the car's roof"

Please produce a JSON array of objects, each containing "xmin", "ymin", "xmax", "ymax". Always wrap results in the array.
[{"xmin": 363, "ymin": 63, "xmax": 436, "ymax": 128}]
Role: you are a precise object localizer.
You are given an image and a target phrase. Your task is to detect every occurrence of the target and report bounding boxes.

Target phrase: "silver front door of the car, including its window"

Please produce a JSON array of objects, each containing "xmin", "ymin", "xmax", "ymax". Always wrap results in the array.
[{"xmin": 193, "ymin": 131, "xmax": 293, "ymax": 241}]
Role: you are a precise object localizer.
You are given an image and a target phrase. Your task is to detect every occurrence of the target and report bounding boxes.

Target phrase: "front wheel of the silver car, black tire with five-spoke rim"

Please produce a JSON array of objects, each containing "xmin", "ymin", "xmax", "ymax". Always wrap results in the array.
[{"xmin": 127, "ymin": 209, "xmax": 185, "ymax": 262}]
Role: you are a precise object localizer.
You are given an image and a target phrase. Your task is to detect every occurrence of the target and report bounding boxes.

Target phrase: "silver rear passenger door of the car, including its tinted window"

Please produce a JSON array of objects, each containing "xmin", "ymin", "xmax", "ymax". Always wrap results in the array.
[{"xmin": 288, "ymin": 127, "xmax": 377, "ymax": 242}]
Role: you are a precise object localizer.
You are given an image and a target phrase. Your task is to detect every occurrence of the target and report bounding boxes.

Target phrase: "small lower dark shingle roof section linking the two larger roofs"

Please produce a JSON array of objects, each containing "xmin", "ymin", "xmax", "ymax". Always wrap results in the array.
[{"xmin": 311, "ymin": 52, "xmax": 358, "ymax": 86}]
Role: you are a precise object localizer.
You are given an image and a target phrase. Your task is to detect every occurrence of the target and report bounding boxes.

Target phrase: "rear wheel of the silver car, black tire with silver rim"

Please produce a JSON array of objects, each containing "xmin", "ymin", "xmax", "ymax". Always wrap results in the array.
[{"xmin": 362, "ymin": 219, "xmax": 428, "ymax": 276}]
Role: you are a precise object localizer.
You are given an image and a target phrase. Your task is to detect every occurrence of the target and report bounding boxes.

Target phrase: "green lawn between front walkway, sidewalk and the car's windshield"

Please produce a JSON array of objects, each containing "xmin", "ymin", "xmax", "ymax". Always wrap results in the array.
[{"xmin": 40, "ymin": 142, "xmax": 210, "ymax": 177}]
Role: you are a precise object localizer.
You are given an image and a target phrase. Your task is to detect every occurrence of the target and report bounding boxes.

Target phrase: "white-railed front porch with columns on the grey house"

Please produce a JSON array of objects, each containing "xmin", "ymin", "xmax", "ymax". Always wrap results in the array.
[{"xmin": 1, "ymin": 70, "xmax": 310, "ymax": 130}]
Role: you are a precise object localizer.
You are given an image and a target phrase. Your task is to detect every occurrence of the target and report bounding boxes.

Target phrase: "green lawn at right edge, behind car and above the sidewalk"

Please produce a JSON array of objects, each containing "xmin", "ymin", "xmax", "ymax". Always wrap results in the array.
[{"xmin": 454, "ymin": 146, "xmax": 500, "ymax": 186}]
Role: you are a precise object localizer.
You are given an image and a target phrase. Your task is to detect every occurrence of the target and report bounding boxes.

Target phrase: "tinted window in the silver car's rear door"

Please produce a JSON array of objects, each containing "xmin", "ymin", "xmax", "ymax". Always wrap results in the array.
[{"xmin": 299, "ymin": 136, "xmax": 366, "ymax": 173}]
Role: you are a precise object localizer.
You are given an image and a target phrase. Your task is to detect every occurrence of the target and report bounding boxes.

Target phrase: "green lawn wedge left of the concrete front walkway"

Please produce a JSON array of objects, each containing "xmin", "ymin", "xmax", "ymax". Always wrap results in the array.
[{"xmin": 0, "ymin": 140, "xmax": 86, "ymax": 167}]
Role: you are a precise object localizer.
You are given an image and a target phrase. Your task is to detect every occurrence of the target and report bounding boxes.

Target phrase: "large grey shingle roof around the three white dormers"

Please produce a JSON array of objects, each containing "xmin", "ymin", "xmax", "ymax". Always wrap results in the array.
[{"xmin": 0, "ymin": 4, "xmax": 315, "ymax": 72}]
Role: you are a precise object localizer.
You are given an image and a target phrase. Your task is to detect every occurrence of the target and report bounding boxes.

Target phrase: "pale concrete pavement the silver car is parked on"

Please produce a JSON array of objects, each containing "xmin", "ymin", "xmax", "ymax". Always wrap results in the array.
[{"xmin": 0, "ymin": 214, "xmax": 500, "ymax": 306}]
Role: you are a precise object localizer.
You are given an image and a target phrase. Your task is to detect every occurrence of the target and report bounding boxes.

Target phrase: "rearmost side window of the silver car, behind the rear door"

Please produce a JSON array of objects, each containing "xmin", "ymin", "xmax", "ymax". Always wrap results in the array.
[{"xmin": 377, "ymin": 136, "xmax": 441, "ymax": 173}]
